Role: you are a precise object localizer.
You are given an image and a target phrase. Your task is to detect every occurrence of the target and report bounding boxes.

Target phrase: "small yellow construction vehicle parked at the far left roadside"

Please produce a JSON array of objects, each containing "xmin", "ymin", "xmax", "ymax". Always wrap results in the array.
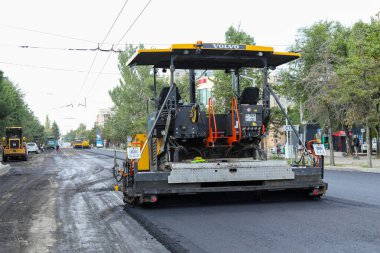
[{"xmin": 2, "ymin": 127, "xmax": 28, "ymax": 162}]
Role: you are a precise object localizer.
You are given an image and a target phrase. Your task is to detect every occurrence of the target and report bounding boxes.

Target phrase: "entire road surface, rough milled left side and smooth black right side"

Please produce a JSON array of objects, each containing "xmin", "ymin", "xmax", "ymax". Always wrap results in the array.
[{"xmin": 0, "ymin": 149, "xmax": 380, "ymax": 253}]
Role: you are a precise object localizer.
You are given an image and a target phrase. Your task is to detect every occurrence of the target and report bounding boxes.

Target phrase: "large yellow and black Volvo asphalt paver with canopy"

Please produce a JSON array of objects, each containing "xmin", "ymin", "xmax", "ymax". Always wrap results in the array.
[{"xmin": 114, "ymin": 41, "xmax": 327, "ymax": 204}]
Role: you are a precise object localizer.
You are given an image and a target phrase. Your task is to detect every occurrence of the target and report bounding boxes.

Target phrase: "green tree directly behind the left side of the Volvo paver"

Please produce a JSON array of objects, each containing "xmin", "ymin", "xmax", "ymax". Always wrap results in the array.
[{"xmin": 103, "ymin": 42, "xmax": 193, "ymax": 145}]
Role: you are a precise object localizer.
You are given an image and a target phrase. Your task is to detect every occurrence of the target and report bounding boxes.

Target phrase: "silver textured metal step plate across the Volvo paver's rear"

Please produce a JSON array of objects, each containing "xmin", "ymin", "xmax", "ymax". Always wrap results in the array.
[{"xmin": 168, "ymin": 161, "xmax": 295, "ymax": 184}]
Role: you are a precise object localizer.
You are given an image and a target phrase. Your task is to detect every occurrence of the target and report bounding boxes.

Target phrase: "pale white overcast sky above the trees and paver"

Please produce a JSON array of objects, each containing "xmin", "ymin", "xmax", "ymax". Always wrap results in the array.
[{"xmin": 0, "ymin": 0, "xmax": 380, "ymax": 134}]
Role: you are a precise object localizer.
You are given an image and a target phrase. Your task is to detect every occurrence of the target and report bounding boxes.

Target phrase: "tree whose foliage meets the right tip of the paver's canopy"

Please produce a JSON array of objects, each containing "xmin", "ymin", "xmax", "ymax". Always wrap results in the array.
[{"xmin": 278, "ymin": 21, "xmax": 345, "ymax": 165}]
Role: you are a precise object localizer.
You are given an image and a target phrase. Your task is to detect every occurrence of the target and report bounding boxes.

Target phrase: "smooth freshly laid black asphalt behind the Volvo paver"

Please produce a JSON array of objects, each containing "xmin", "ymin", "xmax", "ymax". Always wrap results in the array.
[{"xmin": 127, "ymin": 171, "xmax": 380, "ymax": 252}]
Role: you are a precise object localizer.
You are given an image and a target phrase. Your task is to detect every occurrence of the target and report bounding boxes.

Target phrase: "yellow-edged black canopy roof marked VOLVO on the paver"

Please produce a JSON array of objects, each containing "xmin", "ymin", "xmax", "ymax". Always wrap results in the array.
[{"xmin": 127, "ymin": 42, "xmax": 300, "ymax": 69}]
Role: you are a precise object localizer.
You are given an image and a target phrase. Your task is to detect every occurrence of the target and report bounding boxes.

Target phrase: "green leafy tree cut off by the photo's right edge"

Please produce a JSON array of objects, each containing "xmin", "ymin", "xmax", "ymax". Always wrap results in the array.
[{"xmin": 338, "ymin": 19, "xmax": 380, "ymax": 164}]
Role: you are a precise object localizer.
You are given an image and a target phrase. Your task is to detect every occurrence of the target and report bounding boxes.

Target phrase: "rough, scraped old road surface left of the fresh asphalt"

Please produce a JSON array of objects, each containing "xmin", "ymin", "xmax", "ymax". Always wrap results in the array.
[{"xmin": 0, "ymin": 149, "xmax": 167, "ymax": 253}]
